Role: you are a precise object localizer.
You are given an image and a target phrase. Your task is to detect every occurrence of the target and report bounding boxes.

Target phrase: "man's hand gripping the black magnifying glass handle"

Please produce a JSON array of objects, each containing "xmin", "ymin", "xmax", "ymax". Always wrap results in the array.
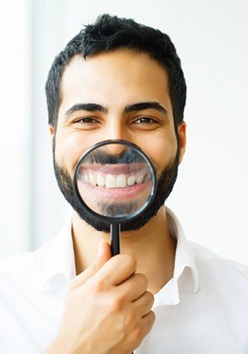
[{"xmin": 45, "ymin": 242, "xmax": 155, "ymax": 354}]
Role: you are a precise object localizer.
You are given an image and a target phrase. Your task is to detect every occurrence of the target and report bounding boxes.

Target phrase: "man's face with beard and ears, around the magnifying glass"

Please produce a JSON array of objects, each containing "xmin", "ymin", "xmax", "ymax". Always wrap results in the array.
[{"xmin": 51, "ymin": 49, "xmax": 185, "ymax": 232}]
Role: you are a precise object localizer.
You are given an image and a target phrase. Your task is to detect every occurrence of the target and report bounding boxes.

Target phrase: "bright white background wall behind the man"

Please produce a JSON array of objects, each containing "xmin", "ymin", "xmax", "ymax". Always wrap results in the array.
[{"xmin": 0, "ymin": 0, "xmax": 248, "ymax": 264}]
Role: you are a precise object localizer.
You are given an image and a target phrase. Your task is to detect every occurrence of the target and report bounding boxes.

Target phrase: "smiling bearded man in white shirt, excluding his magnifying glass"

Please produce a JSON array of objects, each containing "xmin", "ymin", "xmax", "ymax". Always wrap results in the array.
[{"xmin": 0, "ymin": 15, "xmax": 248, "ymax": 354}]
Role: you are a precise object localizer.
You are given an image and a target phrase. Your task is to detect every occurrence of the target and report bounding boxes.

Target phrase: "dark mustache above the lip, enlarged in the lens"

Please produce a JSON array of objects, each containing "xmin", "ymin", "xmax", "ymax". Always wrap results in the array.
[{"xmin": 81, "ymin": 150, "xmax": 144, "ymax": 165}]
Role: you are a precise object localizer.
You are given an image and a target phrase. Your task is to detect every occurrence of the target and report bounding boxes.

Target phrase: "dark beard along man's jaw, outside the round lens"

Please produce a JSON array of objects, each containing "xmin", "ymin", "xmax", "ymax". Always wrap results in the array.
[{"xmin": 53, "ymin": 147, "xmax": 180, "ymax": 233}]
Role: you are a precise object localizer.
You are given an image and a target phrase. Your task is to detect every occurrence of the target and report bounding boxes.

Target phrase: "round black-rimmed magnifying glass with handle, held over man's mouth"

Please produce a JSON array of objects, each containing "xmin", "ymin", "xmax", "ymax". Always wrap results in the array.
[{"xmin": 73, "ymin": 139, "xmax": 157, "ymax": 256}]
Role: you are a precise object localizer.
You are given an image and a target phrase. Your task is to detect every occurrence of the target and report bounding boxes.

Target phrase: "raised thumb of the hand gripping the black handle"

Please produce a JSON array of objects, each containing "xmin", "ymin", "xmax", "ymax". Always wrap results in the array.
[{"xmin": 70, "ymin": 240, "xmax": 111, "ymax": 287}]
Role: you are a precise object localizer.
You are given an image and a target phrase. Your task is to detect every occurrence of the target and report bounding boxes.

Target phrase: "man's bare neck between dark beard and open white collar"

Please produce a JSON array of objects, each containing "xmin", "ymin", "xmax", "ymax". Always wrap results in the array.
[{"xmin": 72, "ymin": 207, "xmax": 176, "ymax": 293}]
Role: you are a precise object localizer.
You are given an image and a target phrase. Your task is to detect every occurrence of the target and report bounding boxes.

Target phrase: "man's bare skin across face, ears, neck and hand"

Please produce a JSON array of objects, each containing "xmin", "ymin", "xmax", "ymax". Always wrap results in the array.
[{"xmin": 46, "ymin": 49, "xmax": 186, "ymax": 354}]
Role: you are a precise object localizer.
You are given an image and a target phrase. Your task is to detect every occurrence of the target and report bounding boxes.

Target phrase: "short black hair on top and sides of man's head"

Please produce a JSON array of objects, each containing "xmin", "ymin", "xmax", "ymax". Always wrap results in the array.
[{"xmin": 46, "ymin": 14, "xmax": 186, "ymax": 128}]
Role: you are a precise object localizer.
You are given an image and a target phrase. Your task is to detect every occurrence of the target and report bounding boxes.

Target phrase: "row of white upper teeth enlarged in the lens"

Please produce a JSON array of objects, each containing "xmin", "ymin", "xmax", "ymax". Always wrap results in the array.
[{"xmin": 81, "ymin": 172, "xmax": 151, "ymax": 188}]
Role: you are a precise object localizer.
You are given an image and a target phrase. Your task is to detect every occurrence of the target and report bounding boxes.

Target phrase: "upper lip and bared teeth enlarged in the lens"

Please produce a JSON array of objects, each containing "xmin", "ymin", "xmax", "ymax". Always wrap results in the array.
[{"xmin": 79, "ymin": 165, "xmax": 152, "ymax": 189}]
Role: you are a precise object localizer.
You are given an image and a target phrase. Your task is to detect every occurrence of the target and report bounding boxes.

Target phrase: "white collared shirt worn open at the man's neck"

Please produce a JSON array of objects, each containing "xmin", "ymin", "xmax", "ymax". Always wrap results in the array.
[{"xmin": 0, "ymin": 210, "xmax": 248, "ymax": 354}]
